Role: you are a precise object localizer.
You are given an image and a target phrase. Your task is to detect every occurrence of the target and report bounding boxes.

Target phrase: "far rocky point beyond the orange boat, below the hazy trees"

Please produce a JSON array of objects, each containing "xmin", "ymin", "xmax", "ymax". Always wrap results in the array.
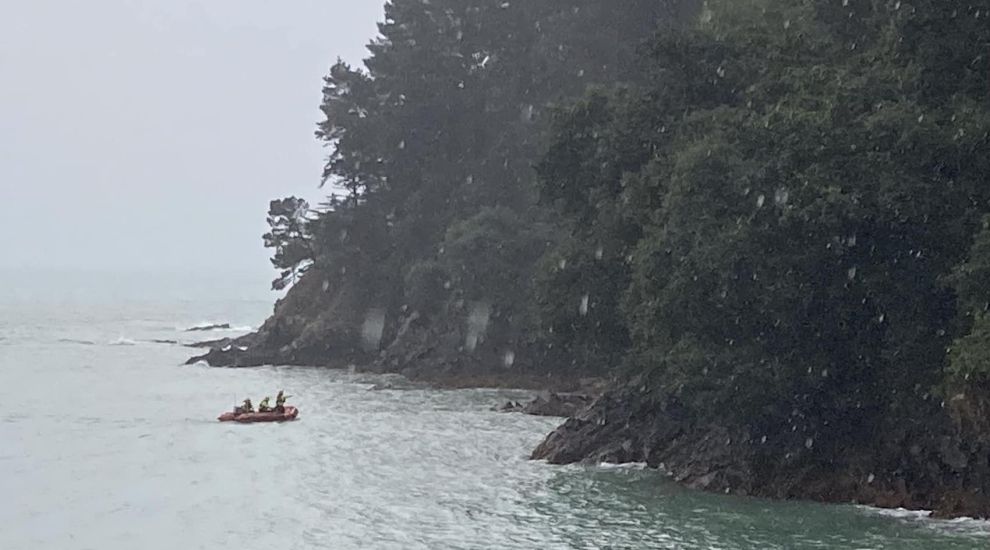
[{"xmin": 186, "ymin": 270, "xmax": 608, "ymax": 395}]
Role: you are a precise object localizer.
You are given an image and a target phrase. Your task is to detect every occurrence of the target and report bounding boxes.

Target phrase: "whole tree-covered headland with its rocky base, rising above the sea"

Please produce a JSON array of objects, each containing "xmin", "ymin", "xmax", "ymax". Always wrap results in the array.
[{"xmin": 194, "ymin": 0, "xmax": 990, "ymax": 516}]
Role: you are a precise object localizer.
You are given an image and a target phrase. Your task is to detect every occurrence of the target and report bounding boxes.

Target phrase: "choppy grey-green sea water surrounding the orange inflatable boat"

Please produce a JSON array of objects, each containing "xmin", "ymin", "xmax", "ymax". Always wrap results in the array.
[{"xmin": 0, "ymin": 278, "xmax": 990, "ymax": 550}]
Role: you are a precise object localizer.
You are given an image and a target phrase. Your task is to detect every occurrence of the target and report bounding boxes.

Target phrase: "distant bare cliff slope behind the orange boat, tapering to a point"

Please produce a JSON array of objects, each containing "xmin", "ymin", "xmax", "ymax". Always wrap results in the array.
[{"xmin": 187, "ymin": 270, "xmax": 602, "ymax": 393}]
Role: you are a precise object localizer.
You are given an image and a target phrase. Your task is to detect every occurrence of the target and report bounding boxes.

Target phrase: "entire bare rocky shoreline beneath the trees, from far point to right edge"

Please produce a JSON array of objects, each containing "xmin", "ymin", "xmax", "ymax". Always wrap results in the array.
[{"xmin": 187, "ymin": 274, "xmax": 990, "ymax": 518}]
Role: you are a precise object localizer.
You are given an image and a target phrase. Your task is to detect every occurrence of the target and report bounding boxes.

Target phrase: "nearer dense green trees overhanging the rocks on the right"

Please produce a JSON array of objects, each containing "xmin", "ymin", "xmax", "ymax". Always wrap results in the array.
[{"xmin": 542, "ymin": 0, "xmax": 990, "ymax": 433}]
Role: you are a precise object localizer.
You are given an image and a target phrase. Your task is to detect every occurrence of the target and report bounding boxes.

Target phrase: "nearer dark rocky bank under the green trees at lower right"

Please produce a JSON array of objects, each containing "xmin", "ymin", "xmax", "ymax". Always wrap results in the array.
[{"xmin": 532, "ymin": 382, "xmax": 990, "ymax": 518}]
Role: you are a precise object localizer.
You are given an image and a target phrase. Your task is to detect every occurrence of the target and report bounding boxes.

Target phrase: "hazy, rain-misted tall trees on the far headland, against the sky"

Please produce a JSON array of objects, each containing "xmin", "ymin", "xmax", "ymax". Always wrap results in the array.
[{"xmin": 269, "ymin": 0, "xmax": 693, "ymax": 376}]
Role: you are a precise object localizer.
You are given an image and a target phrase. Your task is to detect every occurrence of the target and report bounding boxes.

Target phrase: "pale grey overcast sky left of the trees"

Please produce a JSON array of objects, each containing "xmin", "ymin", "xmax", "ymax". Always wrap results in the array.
[{"xmin": 0, "ymin": 0, "xmax": 384, "ymax": 280}]
